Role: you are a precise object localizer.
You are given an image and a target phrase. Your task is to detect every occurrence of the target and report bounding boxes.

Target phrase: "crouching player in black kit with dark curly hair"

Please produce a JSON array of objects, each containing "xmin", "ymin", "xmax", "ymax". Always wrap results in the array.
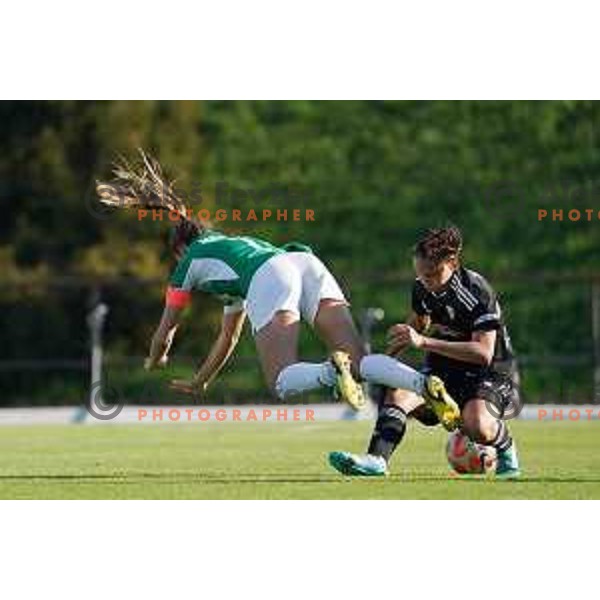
[{"xmin": 329, "ymin": 227, "xmax": 520, "ymax": 478}]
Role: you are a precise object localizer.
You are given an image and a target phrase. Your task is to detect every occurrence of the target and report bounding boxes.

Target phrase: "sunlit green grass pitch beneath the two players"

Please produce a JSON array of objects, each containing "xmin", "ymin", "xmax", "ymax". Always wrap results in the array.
[{"xmin": 0, "ymin": 421, "xmax": 600, "ymax": 499}]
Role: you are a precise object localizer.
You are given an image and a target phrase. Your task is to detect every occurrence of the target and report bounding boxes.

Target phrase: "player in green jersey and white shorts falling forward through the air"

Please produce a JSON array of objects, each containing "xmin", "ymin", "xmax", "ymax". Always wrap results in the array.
[{"xmin": 97, "ymin": 152, "xmax": 458, "ymax": 418}]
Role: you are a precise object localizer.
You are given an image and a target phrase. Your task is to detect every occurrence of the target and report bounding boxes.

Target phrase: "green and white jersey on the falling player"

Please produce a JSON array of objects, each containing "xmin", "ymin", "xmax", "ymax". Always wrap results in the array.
[{"xmin": 170, "ymin": 231, "xmax": 286, "ymax": 305}]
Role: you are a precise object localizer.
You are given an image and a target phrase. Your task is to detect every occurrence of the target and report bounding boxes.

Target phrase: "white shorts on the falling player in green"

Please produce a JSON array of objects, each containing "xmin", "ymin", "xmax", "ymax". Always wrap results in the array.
[{"xmin": 245, "ymin": 252, "xmax": 348, "ymax": 333}]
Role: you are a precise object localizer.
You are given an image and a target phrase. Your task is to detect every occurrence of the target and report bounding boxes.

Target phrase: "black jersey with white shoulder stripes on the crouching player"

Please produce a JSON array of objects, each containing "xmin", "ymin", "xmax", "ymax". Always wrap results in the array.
[{"xmin": 412, "ymin": 268, "xmax": 516, "ymax": 373}]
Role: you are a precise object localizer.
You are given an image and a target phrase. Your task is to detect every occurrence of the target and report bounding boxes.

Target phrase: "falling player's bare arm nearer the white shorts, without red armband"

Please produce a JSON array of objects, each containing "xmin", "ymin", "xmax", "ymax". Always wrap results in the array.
[{"xmin": 171, "ymin": 310, "xmax": 246, "ymax": 394}]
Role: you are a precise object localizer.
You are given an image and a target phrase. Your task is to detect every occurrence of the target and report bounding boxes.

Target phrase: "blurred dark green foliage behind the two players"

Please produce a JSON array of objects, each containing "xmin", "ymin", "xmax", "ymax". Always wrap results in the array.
[{"xmin": 0, "ymin": 101, "xmax": 600, "ymax": 405}]
